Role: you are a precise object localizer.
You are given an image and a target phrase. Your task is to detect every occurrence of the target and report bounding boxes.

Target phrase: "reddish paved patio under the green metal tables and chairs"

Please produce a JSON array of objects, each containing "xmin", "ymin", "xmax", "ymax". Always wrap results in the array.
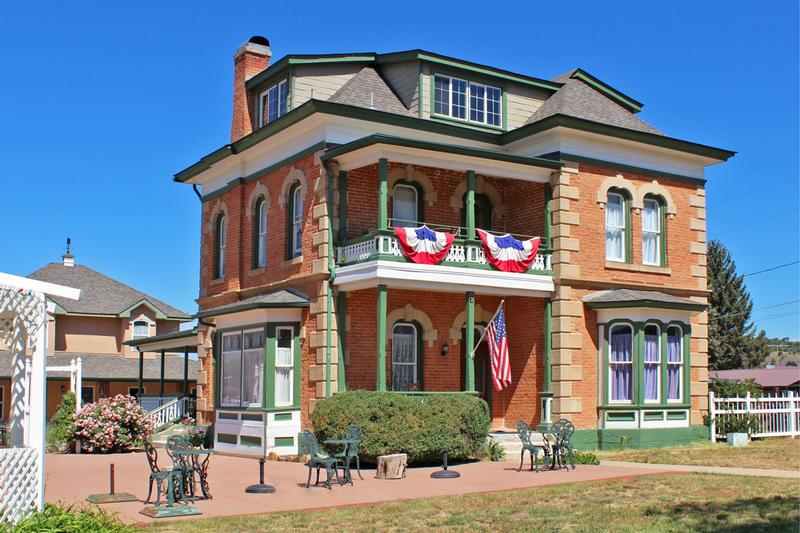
[{"xmin": 46, "ymin": 450, "xmax": 667, "ymax": 523}]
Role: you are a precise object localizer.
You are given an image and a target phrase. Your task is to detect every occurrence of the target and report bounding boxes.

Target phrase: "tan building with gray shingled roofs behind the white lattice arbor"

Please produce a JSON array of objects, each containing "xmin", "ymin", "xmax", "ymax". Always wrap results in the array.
[{"xmin": 0, "ymin": 251, "xmax": 198, "ymax": 420}]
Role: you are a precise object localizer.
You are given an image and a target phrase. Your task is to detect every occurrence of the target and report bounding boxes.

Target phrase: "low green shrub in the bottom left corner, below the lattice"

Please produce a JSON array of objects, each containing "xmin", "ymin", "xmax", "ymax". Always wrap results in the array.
[{"xmin": 5, "ymin": 503, "xmax": 135, "ymax": 533}]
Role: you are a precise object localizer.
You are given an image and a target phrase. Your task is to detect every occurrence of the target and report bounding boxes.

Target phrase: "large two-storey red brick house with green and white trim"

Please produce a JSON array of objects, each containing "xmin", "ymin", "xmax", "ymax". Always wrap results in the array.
[{"xmin": 175, "ymin": 37, "xmax": 733, "ymax": 453}]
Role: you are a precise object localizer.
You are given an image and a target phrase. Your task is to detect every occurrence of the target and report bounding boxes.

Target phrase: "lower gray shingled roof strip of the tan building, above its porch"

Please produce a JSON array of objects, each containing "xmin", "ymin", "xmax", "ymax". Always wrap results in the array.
[{"xmin": 0, "ymin": 351, "xmax": 200, "ymax": 381}]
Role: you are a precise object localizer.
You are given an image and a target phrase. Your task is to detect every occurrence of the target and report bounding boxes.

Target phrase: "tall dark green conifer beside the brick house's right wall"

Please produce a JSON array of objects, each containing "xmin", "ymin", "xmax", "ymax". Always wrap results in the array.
[{"xmin": 708, "ymin": 241, "xmax": 769, "ymax": 370}]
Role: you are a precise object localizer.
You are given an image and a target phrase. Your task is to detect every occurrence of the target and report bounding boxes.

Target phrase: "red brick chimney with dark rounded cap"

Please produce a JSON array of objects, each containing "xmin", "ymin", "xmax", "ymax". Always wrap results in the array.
[{"xmin": 231, "ymin": 35, "xmax": 272, "ymax": 142}]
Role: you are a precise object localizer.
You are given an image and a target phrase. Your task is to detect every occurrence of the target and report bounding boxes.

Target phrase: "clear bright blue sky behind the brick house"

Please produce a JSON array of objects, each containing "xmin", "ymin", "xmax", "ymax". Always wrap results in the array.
[{"xmin": 0, "ymin": 0, "xmax": 800, "ymax": 338}]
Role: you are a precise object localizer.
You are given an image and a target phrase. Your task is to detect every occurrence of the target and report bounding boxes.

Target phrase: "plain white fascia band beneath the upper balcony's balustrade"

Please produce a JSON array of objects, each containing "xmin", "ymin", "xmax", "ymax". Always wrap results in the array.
[{"xmin": 334, "ymin": 261, "xmax": 554, "ymax": 298}]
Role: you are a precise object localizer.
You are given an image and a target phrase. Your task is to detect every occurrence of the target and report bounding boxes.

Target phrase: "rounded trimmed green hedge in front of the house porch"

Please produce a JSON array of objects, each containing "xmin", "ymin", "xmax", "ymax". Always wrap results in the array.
[{"xmin": 311, "ymin": 390, "xmax": 490, "ymax": 464}]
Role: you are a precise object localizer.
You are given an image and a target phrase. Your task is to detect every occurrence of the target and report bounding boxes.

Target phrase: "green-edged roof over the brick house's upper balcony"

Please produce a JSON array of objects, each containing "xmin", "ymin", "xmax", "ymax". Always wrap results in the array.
[{"xmin": 321, "ymin": 134, "xmax": 564, "ymax": 181}]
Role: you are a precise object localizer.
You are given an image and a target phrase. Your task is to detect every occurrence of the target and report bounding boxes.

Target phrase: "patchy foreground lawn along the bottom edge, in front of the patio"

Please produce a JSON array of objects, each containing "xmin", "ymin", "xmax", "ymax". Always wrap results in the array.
[{"xmin": 147, "ymin": 474, "xmax": 800, "ymax": 533}]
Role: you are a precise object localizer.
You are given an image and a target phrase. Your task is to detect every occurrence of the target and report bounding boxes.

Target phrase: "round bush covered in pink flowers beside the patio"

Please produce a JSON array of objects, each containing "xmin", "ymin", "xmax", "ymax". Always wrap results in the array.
[{"xmin": 75, "ymin": 394, "xmax": 155, "ymax": 453}]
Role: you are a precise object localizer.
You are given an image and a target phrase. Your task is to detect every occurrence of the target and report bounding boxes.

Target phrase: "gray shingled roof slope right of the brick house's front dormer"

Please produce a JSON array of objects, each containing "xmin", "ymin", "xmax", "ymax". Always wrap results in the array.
[{"xmin": 526, "ymin": 74, "xmax": 664, "ymax": 135}]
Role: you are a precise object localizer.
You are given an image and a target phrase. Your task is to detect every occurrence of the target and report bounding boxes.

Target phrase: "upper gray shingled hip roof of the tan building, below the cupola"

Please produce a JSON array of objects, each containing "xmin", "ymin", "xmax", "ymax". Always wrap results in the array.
[{"xmin": 28, "ymin": 263, "xmax": 191, "ymax": 320}]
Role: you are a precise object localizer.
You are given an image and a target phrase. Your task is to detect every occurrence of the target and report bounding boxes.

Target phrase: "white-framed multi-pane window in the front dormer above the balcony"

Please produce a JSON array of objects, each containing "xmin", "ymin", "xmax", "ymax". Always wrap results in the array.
[{"xmin": 433, "ymin": 74, "xmax": 503, "ymax": 127}]
